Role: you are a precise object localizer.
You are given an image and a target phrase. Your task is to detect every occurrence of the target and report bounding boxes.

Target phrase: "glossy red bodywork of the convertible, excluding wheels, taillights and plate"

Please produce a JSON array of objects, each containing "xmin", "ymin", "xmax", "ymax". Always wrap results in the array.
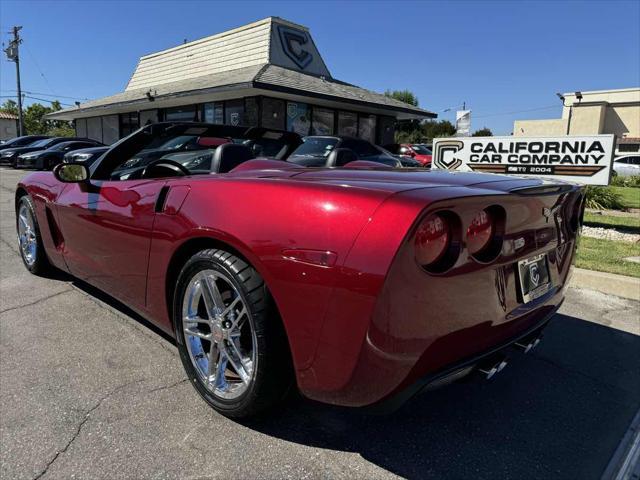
[{"xmin": 15, "ymin": 160, "xmax": 581, "ymax": 406}]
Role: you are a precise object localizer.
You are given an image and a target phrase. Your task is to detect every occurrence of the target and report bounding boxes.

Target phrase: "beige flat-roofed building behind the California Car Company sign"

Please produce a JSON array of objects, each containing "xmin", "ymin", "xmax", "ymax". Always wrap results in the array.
[{"xmin": 513, "ymin": 87, "xmax": 640, "ymax": 155}]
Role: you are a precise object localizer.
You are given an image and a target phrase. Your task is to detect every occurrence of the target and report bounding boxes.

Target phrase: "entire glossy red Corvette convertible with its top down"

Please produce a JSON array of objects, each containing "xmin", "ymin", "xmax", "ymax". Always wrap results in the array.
[{"xmin": 15, "ymin": 124, "xmax": 584, "ymax": 417}]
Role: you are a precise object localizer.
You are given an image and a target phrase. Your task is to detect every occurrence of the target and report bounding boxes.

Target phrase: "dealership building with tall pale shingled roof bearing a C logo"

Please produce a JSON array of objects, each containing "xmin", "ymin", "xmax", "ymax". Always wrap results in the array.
[{"xmin": 48, "ymin": 17, "xmax": 436, "ymax": 144}]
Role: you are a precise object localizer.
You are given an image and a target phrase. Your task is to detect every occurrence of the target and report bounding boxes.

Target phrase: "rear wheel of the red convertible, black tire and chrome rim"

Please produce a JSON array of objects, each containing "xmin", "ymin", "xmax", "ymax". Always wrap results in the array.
[{"xmin": 173, "ymin": 249, "xmax": 293, "ymax": 418}]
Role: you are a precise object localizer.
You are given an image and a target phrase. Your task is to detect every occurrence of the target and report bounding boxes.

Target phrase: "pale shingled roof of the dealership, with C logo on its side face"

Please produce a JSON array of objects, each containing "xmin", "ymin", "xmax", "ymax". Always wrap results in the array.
[{"xmin": 48, "ymin": 17, "xmax": 436, "ymax": 120}]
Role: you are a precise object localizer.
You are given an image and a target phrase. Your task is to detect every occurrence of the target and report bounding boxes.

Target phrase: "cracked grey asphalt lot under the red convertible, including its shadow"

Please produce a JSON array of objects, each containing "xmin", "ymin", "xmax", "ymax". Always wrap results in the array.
[{"xmin": 0, "ymin": 169, "xmax": 640, "ymax": 479}]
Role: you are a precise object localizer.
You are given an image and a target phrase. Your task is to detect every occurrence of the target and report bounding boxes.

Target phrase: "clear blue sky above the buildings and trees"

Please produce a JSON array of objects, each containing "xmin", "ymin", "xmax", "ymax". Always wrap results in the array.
[{"xmin": 0, "ymin": 0, "xmax": 640, "ymax": 135}]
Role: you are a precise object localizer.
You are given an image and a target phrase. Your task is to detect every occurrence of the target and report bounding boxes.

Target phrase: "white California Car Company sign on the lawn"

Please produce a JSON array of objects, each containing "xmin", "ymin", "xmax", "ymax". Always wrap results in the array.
[{"xmin": 431, "ymin": 135, "xmax": 614, "ymax": 185}]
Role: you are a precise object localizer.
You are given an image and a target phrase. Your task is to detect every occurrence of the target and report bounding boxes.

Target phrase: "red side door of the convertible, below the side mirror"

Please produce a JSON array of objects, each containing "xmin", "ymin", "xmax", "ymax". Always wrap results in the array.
[{"xmin": 57, "ymin": 174, "xmax": 165, "ymax": 307}]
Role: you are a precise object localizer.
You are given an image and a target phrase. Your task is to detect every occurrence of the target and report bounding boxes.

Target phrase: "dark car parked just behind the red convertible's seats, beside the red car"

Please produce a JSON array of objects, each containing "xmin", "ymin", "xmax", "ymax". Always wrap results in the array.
[{"xmin": 287, "ymin": 135, "xmax": 402, "ymax": 168}]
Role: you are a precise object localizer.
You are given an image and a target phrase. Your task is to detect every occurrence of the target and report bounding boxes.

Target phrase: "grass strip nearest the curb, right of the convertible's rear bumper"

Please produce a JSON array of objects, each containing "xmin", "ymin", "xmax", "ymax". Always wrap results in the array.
[{"xmin": 576, "ymin": 237, "xmax": 640, "ymax": 278}]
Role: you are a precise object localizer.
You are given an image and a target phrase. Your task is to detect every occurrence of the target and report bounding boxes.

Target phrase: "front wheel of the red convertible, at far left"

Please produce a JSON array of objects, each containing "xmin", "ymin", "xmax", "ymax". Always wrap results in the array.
[{"xmin": 16, "ymin": 195, "xmax": 53, "ymax": 276}]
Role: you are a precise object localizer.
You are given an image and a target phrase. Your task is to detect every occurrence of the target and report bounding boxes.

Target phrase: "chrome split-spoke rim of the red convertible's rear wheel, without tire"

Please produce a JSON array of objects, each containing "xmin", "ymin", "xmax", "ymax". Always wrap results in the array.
[{"xmin": 182, "ymin": 270, "xmax": 257, "ymax": 399}]
